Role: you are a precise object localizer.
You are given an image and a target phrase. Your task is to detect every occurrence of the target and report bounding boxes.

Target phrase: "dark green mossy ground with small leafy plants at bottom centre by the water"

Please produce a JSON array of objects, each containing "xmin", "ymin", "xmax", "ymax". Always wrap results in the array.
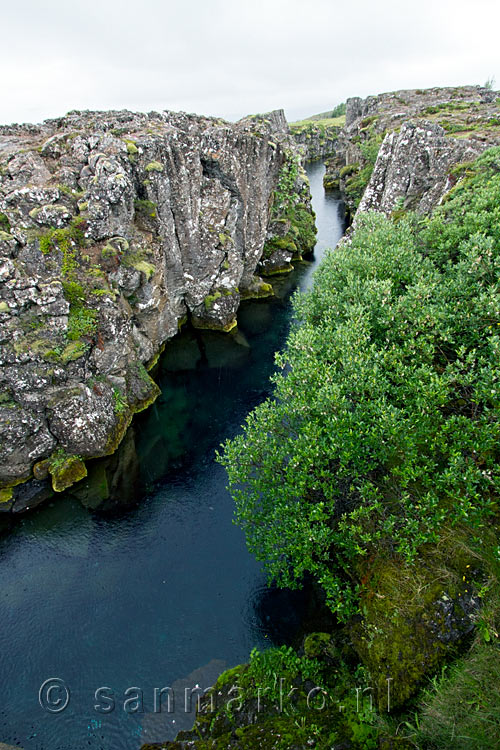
[{"xmin": 142, "ymin": 647, "xmax": 378, "ymax": 750}]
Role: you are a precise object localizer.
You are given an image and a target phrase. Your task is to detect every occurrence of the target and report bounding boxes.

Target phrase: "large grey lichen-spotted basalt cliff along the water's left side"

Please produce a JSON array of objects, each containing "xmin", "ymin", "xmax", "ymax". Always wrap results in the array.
[{"xmin": 0, "ymin": 111, "xmax": 310, "ymax": 510}]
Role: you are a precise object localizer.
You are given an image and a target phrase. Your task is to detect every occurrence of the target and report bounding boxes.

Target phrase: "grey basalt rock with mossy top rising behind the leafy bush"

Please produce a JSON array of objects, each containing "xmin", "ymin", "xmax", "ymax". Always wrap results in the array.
[{"xmin": 325, "ymin": 86, "xmax": 500, "ymax": 214}]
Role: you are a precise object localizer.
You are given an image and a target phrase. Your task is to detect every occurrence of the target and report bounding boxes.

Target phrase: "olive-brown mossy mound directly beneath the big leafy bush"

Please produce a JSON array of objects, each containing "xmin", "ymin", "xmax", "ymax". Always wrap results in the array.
[{"xmin": 350, "ymin": 557, "xmax": 479, "ymax": 711}]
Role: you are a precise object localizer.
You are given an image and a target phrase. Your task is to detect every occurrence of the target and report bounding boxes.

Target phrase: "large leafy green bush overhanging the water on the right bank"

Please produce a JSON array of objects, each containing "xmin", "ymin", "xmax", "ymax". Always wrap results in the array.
[{"xmin": 220, "ymin": 148, "xmax": 500, "ymax": 618}]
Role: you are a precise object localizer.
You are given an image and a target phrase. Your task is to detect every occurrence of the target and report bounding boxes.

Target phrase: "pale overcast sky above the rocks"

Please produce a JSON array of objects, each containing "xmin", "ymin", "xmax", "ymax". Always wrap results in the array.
[{"xmin": 0, "ymin": 0, "xmax": 500, "ymax": 123}]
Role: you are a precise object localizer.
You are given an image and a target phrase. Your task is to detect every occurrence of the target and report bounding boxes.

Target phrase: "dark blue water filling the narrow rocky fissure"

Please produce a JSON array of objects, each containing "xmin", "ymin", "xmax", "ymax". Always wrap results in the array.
[{"xmin": 0, "ymin": 164, "xmax": 343, "ymax": 750}]
